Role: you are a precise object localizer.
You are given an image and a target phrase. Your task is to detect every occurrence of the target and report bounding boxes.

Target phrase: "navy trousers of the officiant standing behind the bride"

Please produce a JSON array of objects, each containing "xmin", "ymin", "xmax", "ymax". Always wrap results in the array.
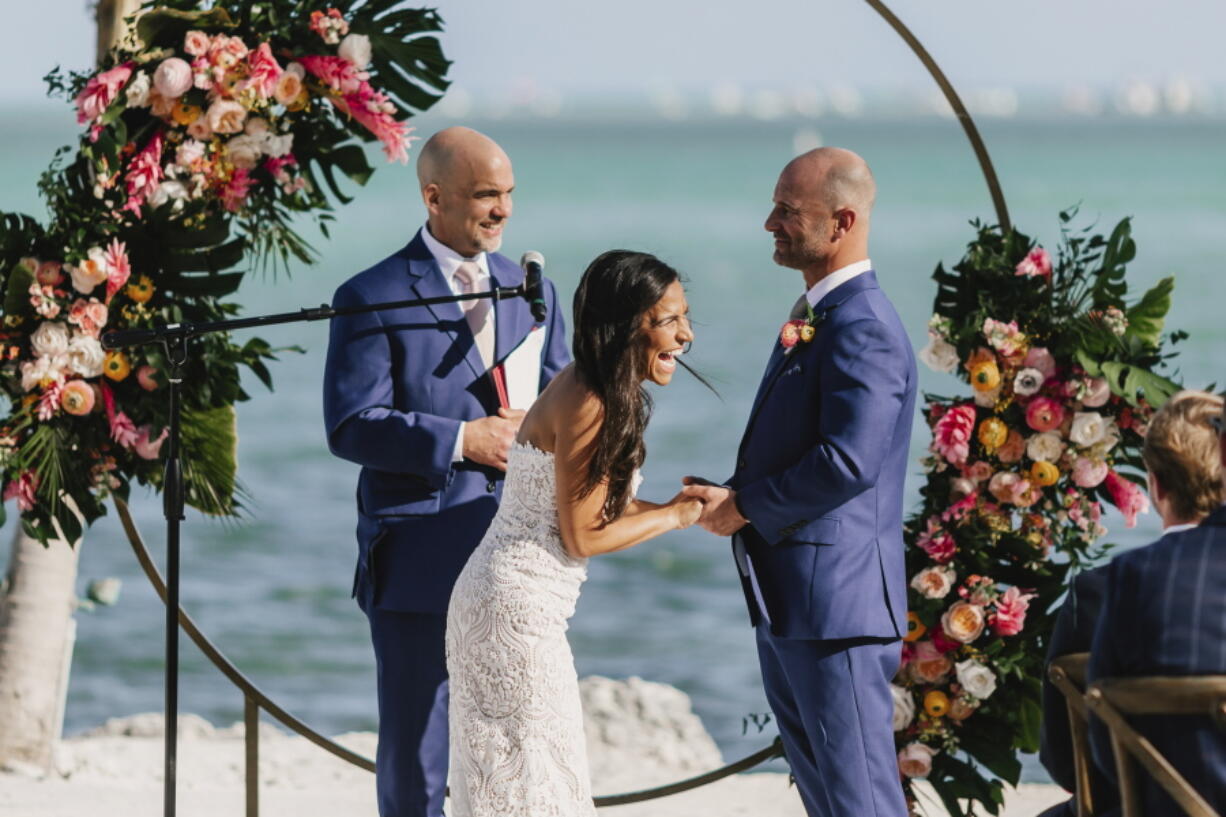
[{"xmin": 367, "ymin": 610, "xmax": 447, "ymax": 817}]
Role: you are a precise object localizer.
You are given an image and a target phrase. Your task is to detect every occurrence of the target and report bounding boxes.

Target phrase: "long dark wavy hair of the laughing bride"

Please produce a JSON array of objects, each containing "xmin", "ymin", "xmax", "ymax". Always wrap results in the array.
[{"xmin": 574, "ymin": 250, "xmax": 680, "ymax": 523}]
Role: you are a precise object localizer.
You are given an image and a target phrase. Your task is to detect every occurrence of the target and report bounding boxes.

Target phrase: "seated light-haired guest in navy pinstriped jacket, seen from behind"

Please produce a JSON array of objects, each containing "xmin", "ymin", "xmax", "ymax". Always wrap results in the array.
[{"xmin": 1090, "ymin": 393, "xmax": 1226, "ymax": 817}]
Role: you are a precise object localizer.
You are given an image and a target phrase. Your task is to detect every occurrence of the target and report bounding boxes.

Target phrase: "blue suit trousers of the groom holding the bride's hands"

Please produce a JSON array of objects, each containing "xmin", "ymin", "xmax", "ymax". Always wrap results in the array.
[{"xmin": 756, "ymin": 623, "xmax": 907, "ymax": 817}]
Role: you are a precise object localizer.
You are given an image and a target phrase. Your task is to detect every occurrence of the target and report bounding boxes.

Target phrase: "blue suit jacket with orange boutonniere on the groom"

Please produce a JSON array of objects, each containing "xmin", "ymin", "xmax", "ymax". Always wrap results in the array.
[{"xmin": 728, "ymin": 271, "xmax": 916, "ymax": 639}]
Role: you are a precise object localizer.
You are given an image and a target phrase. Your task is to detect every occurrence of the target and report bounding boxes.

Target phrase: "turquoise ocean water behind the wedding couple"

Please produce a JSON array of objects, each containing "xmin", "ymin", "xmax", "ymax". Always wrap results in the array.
[{"xmin": 0, "ymin": 109, "xmax": 1226, "ymax": 780}]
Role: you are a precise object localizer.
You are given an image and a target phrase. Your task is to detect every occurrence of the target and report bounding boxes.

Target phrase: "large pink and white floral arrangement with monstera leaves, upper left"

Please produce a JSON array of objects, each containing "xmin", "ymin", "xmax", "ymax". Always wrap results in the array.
[{"xmin": 0, "ymin": 0, "xmax": 450, "ymax": 542}]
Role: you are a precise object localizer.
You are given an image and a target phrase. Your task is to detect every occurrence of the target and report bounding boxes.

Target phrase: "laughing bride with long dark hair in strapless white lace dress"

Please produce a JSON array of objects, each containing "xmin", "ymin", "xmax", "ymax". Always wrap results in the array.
[{"xmin": 446, "ymin": 250, "xmax": 701, "ymax": 817}]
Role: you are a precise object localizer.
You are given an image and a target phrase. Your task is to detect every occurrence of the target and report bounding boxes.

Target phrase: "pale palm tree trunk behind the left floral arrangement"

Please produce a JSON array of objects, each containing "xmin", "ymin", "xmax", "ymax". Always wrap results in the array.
[{"xmin": 0, "ymin": 0, "xmax": 141, "ymax": 769}]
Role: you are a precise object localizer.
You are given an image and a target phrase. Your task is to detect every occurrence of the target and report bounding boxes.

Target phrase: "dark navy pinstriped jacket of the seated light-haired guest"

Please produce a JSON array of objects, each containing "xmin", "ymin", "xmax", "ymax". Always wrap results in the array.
[{"xmin": 1090, "ymin": 507, "xmax": 1226, "ymax": 815}]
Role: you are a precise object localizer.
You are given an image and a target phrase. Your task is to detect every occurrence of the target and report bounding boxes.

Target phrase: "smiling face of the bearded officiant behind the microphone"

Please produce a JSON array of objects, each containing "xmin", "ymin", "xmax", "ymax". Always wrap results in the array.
[{"xmin": 425, "ymin": 146, "xmax": 515, "ymax": 256}]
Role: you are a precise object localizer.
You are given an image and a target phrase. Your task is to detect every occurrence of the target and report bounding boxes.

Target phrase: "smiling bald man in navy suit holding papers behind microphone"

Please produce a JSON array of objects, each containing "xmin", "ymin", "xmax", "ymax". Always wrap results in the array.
[{"xmin": 324, "ymin": 128, "xmax": 569, "ymax": 817}]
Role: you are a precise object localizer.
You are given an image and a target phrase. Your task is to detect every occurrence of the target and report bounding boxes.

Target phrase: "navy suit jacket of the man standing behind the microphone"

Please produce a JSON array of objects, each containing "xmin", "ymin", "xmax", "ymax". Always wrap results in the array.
[{"xmin": 324, "ymin": 229, "xmax": 570, "ymax": 613}]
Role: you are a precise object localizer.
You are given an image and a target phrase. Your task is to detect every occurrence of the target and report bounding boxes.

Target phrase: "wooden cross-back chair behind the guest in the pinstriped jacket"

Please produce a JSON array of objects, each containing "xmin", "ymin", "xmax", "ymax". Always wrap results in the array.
[{"xmin": 1085, "ymin": 675, "xmax": 1226, "ymax": 817}]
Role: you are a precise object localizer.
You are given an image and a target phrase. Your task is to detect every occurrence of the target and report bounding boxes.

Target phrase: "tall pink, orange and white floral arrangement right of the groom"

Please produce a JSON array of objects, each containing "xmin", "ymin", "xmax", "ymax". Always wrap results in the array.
[{"xmin": 893, "ymin": 212, "xmax": 1186, "ymax": 815}]
